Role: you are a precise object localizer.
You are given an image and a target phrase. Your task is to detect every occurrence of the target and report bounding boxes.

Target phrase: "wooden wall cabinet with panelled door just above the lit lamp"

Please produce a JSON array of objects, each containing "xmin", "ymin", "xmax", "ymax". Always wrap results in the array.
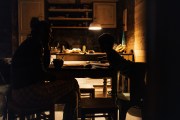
[{"xmin": 93, "ymin": 2, "xmax": 116, "ymax": 28}]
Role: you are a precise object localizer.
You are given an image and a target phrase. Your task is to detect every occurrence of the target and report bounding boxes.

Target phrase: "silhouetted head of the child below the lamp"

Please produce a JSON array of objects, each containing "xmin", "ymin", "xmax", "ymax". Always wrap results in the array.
[{"xmin": 98, "ymin": 33, "xmax": 115, "ymax": 52}]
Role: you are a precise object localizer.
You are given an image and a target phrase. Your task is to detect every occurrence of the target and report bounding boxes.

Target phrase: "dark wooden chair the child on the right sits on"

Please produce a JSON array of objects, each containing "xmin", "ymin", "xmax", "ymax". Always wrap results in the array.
[{"xmin": 117, "ymin": 62, "xmax": 146, "ymax": 120}]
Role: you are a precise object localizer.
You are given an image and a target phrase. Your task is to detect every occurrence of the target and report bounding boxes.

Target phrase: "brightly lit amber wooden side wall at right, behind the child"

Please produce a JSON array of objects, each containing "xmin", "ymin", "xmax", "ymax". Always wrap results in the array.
[{"xmin": 134, "ymin": 0, "xmax": 146, "ymax": 62}]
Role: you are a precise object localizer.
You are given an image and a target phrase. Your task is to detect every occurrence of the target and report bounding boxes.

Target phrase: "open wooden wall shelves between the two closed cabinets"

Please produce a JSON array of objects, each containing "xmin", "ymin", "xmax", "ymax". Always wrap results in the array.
[{"xmin": 47, "ymin": 2, "xmax": 93, "ymax": 29}]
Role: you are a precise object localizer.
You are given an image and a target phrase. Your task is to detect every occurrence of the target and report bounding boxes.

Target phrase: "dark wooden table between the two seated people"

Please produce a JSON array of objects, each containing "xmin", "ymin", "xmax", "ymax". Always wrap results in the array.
[{"xmin": 49, "ymin": 65, "xmax": 117, "ymax": 98}]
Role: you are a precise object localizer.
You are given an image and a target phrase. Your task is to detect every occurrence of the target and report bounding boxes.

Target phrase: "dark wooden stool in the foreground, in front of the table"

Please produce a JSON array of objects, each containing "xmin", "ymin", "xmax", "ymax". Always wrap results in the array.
[{"xmin": 80, "ymin": 98, "xmax": 118, "ymax": 120}]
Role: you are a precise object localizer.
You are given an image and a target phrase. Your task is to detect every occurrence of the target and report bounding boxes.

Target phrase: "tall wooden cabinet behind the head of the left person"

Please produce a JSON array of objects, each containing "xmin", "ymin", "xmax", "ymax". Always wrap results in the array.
[{"xmin": 18, "ymin": 0, "xmax": 44, "ymax": 44}]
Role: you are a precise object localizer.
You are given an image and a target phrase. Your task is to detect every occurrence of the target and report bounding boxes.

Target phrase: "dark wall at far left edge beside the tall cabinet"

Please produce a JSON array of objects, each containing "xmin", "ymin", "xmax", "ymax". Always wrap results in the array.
[{"xmin": 0, "ymin": 0, "xmax": 12, "ymax": 58}]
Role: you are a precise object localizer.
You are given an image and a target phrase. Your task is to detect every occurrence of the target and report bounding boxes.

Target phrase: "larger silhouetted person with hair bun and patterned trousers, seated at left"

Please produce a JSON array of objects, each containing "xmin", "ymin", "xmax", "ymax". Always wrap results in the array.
[{"xmin": 12, "ymin": 18, "xmax": 80, "ymax": 120}]
